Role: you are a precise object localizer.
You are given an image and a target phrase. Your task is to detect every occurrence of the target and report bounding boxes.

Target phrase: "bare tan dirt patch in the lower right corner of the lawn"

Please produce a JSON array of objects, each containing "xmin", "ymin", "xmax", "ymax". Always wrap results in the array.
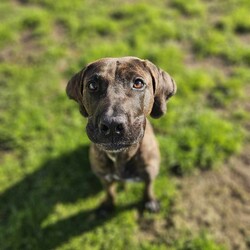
[{"xmin": 171, "ymin": 146, "xmax": 250, "ymax": 250}]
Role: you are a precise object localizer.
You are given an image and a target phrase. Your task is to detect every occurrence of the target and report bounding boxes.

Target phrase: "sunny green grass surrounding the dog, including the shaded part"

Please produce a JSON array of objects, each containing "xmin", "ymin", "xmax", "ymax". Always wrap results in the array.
[{"xmin": 0, "ymin": 0, "xmax": 250, "ymax": 250}]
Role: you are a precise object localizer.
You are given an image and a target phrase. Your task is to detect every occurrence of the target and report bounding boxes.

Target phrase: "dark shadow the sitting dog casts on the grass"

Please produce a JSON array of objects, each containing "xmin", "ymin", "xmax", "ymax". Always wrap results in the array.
[{"xmin": 0, "ymin": 146, "xmax": 137, "ymax": 249}]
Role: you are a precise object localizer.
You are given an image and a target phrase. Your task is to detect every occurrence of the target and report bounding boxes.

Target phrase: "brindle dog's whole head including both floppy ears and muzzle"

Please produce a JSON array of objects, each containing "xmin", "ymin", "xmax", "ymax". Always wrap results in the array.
[{"xmin": 66, "ymin": 57, "xmax": 176, "ymax": 152}]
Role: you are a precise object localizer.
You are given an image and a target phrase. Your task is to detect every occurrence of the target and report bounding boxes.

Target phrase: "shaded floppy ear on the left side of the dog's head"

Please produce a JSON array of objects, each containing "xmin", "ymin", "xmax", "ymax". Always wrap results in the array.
[{"xmin": 66, "ymin": 69, "xmax": 88, "ymax": 117}]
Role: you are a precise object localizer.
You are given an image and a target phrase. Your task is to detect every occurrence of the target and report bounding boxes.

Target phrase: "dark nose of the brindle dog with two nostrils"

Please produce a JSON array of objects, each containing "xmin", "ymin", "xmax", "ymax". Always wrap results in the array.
[{"xmin": 99, "ymin": 116, "xmax": 125, "ymax": 136}]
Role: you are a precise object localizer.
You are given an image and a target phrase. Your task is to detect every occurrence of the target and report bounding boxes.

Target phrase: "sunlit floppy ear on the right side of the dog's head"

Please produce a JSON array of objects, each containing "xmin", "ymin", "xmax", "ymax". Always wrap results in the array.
[{"xmin": 145, "ymin": 60, "xmax": 177, "ymax": 118}]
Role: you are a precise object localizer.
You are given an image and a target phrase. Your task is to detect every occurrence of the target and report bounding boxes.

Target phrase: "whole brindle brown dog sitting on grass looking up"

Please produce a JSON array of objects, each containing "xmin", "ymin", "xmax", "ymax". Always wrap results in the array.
[{"xmin": 66, "ymin": 57, "xmax": 177, "ymax": 213}]
